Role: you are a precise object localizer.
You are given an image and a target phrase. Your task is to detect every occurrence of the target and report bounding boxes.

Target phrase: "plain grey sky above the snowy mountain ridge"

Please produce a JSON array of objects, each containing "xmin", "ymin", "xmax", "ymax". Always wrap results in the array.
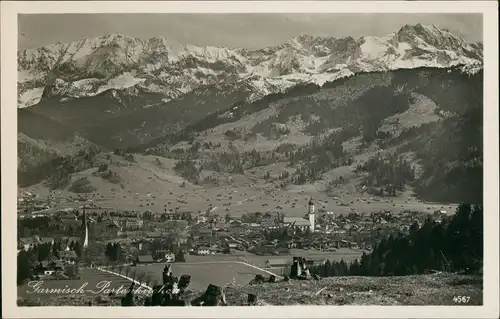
[{"xmin": 18, "ymin": 13, "xmax": 482, "ymax": 49}]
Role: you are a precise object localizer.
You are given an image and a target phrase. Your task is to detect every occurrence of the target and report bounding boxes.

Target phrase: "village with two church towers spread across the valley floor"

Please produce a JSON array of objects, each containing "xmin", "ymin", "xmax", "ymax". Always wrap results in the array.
[{"xmin": 18, "ymin": 193, "xmax": 446, "ymax": 277}]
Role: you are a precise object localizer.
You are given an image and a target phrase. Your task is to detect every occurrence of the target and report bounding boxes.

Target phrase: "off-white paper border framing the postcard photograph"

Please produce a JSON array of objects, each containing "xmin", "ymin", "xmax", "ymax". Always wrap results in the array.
[{"xmin": 1, "ymin": 0, "xmax": 499, "ymax": 318}]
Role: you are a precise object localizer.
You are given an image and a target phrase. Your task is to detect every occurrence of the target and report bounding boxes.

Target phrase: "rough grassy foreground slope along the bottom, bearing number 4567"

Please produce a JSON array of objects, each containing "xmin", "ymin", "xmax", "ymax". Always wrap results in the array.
[{"xmin": 19, "ymin": 273, "xmax": 483, "ymax": 306}]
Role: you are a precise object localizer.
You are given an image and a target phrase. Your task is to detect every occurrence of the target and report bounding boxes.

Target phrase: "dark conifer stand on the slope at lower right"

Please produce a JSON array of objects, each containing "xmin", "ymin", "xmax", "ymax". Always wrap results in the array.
[{"xmin": 311, "ymin": 204, "xmax": 483, "ymax": 277}]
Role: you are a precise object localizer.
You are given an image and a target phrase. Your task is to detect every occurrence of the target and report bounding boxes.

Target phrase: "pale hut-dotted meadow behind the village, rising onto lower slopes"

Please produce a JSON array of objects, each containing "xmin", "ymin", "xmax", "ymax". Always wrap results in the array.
[{"xmin": 21, "ymin": 155, "xmax": 456, "ymax": 217}]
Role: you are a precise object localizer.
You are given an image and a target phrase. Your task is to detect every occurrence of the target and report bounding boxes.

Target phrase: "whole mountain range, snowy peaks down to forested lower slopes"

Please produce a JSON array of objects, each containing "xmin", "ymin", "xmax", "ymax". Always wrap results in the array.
[{"xmin": 18, "ymin": 24, "xmax": 483, "ymax": 206}]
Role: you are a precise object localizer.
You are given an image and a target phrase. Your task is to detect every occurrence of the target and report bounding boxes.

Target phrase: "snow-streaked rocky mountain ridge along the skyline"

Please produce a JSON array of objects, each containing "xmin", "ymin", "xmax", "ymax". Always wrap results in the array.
[{"xmin": 18, "ymin": 24, "xmax": 482, "ymax": 107}]
